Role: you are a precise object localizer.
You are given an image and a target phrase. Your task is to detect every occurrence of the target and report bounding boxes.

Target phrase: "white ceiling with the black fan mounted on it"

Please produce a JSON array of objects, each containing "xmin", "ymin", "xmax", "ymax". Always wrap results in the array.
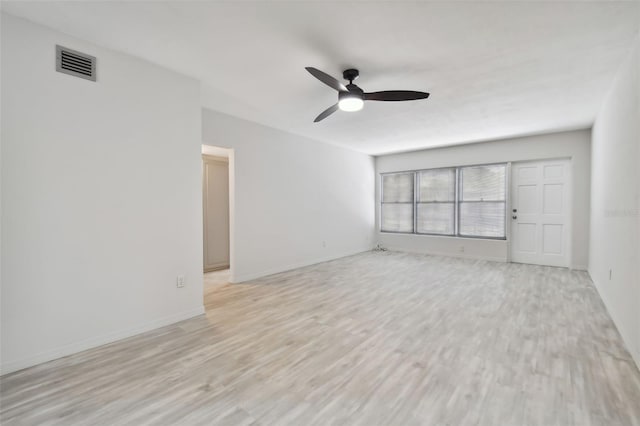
[{"xmin": 2, "ymin": 1, "xmax": 640, "ymax": 154}]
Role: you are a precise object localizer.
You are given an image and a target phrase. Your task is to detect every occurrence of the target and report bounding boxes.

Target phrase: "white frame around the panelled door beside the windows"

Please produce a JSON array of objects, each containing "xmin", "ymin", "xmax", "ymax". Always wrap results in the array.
[{"xmin": 506, "ymin": 157, "xmax": 574, "ymax": 270}]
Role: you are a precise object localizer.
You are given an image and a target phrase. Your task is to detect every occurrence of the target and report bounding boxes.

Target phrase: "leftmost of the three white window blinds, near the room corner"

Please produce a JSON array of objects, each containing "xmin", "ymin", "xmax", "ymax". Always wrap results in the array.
[{"xmin": 380, "ymin": 172, "xmax": 415, "ymax": 233}]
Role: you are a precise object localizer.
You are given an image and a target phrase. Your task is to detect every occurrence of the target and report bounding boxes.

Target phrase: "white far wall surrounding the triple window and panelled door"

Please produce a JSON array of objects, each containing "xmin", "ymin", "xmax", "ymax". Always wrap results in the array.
[{"xmin": 376, "ymin": 130, "xmax": 591, "ymax": 269}]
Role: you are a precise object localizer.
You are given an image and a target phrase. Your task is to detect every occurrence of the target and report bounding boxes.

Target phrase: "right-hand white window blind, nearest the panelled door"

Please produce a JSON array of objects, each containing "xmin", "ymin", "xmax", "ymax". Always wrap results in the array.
[{"xmin": 459, "ymin": 164, "xmax": 506, "ymax": 238}]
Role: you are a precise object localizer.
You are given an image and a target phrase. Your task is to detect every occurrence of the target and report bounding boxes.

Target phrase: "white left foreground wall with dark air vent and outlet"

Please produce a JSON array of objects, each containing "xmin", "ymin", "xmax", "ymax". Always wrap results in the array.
[{"xmin": 1, "ymin": 14, "xmax": 203, "ymax": 373}]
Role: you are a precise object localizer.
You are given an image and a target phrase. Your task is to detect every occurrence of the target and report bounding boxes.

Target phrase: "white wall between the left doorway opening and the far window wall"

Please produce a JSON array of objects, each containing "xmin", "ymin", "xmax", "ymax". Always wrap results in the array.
[{"xmin": 202, "ymin": 110, "xmax": 375, "ymax": 282}]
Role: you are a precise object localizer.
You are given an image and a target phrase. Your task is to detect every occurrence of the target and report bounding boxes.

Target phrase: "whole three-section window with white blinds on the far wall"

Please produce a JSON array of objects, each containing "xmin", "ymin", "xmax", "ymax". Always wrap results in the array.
[{"xmin": 380, "ymin": 164, "xmax": 506, "ymax": 239}]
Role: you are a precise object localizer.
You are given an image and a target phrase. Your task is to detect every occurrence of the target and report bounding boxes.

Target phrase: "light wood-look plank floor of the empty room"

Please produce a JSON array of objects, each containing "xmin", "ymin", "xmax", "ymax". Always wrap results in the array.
[{"xmin": 1, "ymin": 252, "xmax": 640, "ymax": 426}]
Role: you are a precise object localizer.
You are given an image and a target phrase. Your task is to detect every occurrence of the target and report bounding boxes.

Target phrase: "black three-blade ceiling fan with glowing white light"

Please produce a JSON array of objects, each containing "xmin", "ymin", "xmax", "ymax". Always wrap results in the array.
[{"xmin": 305, "ymin": 67, "xmax": 429, "ymax": 123}]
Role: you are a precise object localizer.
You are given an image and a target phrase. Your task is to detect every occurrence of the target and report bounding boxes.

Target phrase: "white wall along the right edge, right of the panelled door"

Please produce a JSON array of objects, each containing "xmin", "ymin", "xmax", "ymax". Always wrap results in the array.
[{"xmin": 589, "ymin": 37, "xmax": 640, "ymax": 366}]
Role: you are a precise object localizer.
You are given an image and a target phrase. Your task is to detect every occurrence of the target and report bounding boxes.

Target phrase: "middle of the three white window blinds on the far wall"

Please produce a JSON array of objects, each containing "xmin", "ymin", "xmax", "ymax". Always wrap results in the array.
[{"xmin": 416, "ymin": 168, "xmax": 456, "ymax": 235}]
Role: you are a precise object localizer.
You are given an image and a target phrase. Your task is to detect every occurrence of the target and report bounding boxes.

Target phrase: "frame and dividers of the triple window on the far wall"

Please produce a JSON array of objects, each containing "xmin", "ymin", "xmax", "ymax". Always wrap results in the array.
[{"xmin": 378, "ymin": 162, "xmax": 509, "ymax": 241}]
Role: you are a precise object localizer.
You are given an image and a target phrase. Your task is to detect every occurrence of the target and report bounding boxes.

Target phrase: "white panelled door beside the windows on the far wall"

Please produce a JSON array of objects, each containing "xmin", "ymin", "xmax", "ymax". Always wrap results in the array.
[{"xmin": 510, "ymin": 160, "xmax": 571, "ymax": 267}]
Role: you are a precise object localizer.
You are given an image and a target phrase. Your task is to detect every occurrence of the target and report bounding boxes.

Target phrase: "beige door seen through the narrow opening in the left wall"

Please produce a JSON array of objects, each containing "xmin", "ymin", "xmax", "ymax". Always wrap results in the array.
[{"xmin": 202, "ymin": 156, "xmax": 229, "ymax": 272}]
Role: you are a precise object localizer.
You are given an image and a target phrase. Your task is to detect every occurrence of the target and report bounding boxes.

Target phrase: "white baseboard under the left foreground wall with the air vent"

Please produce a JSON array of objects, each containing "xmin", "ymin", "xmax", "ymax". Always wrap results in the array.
[{"xmin": 0, "ymin": 306, "xmax": 204, "ymax": 375}]
